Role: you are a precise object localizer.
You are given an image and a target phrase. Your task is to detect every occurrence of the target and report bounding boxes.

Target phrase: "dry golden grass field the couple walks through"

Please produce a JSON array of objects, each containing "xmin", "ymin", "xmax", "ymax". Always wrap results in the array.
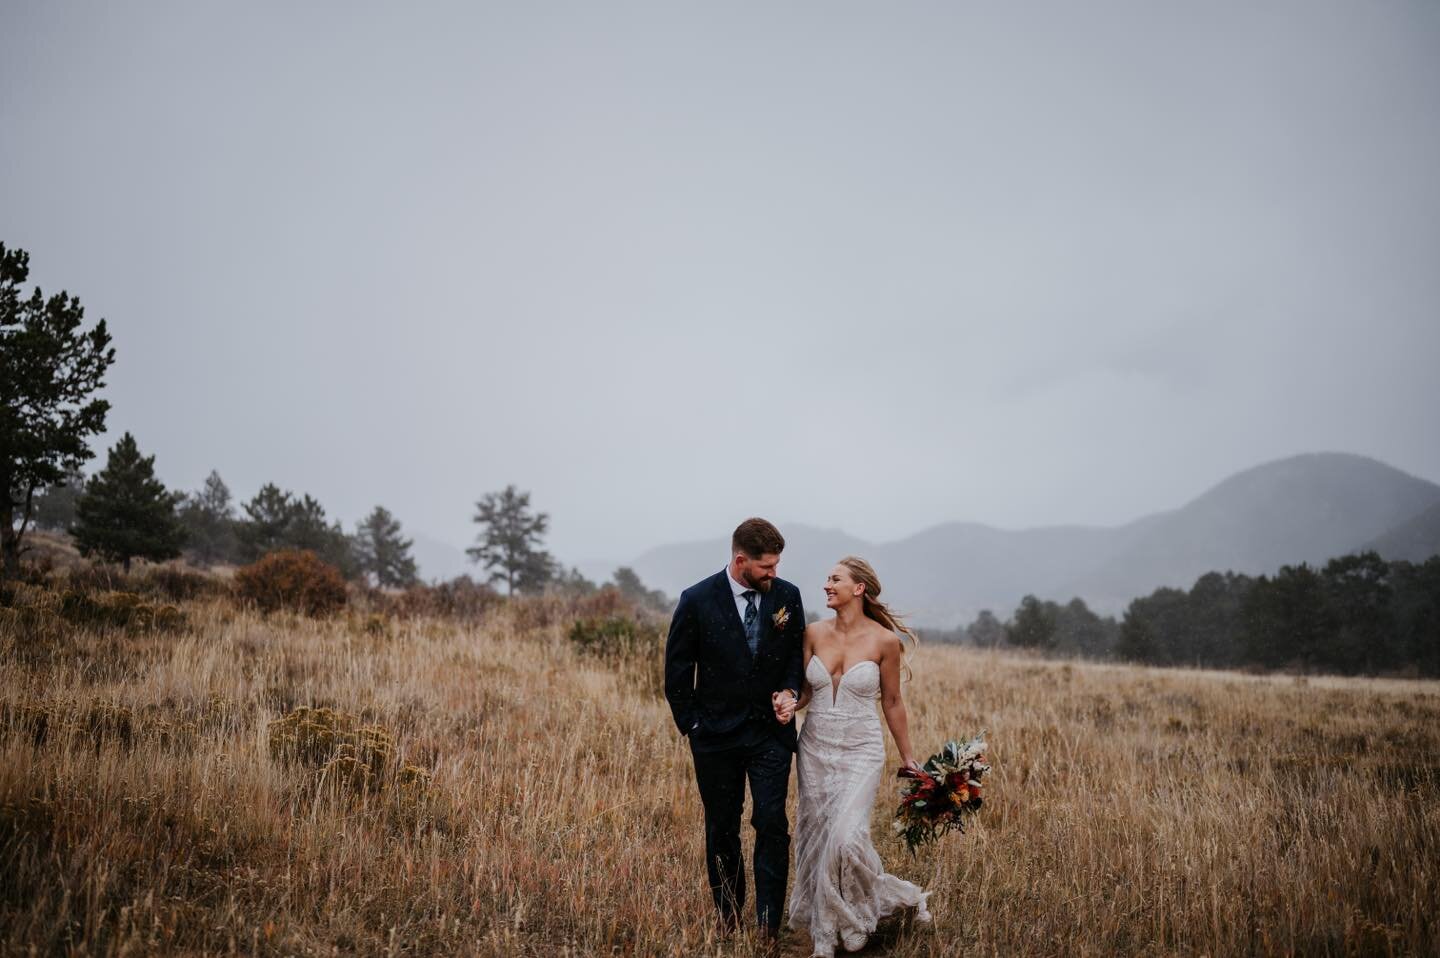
[{"xmin": 0, "ymin": 582, "xmax": 1440, "ymax": 957}]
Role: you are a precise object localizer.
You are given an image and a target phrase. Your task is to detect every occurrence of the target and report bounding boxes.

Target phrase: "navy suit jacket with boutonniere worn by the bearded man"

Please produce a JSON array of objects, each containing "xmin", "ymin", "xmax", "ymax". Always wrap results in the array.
[{"xmin": 665, "ymin": 569, "xmax": 805, "ymax": 751}]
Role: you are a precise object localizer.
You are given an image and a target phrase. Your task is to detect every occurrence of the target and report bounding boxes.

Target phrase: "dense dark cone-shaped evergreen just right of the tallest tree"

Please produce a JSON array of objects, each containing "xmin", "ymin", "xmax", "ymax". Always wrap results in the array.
[{"xmin": 73, "ymin": 432, "xmax": 184, "ymax": 572}]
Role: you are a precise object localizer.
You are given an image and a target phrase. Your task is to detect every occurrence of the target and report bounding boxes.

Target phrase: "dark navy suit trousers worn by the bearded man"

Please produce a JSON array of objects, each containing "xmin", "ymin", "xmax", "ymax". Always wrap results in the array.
[{"xmin": 690, "ymin": 729, "xmax": 793, "ymax": 931}]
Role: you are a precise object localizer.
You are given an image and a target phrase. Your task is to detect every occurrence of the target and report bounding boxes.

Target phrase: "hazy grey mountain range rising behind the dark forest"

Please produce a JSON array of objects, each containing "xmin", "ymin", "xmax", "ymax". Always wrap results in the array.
[{"xmin": 631, "ymin": 452, "xmax": 1440, "ymax": 628}]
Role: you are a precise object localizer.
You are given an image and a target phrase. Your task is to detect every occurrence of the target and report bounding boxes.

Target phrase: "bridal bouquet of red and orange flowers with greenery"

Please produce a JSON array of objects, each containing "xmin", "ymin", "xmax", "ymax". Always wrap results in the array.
[{"xmin": 894, "ymin": 730, "xmax": 989, "ymax": 853}]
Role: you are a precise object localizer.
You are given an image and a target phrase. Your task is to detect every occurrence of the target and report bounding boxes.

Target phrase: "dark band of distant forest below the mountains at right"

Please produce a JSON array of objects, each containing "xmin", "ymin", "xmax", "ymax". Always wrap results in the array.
[{"xmin": 929, "ymin": 552, "xmax": 1440, "ymax": 677}]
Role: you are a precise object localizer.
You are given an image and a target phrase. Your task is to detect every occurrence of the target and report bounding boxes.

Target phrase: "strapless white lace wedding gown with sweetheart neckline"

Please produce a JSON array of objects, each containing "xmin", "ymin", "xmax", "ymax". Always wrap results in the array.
[{"xmin": 789, "ymin": 655, "xmax": 930, "ymax": 958}]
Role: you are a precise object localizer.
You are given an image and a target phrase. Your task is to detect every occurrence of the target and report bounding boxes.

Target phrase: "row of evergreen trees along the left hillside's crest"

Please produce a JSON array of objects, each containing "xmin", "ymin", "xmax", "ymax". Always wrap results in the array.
[{"xmin": 0, "ymin": 237, "xmax": 665, "ymax": 606}]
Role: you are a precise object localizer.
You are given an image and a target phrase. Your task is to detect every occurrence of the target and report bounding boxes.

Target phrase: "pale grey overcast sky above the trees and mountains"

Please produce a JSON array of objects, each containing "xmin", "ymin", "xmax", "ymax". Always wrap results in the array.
[{"xmin": 0, "ymin": 0, "xmax": 1440, "ymax": 562}]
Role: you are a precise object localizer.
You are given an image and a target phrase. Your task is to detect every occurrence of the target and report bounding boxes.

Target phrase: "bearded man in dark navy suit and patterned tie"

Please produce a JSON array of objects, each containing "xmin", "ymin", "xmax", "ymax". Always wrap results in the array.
[{"xmin": 665, "ymin": 519, "xmax": 805, "ymax": 941}]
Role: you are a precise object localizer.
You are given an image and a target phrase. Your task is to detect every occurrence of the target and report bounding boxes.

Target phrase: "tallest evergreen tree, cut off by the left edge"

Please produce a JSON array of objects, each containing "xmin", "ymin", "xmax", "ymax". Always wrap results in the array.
[{"xmin": 0, "ymin": 243, "xmax": 115, "ymax": 581}]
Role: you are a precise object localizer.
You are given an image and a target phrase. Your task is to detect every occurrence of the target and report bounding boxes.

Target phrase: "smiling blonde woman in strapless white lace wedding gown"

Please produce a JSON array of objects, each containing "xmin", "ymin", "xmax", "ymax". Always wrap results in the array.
[{"xmin": 789, "ymin": 556, "xmax": 930, "ymax": 958}]
